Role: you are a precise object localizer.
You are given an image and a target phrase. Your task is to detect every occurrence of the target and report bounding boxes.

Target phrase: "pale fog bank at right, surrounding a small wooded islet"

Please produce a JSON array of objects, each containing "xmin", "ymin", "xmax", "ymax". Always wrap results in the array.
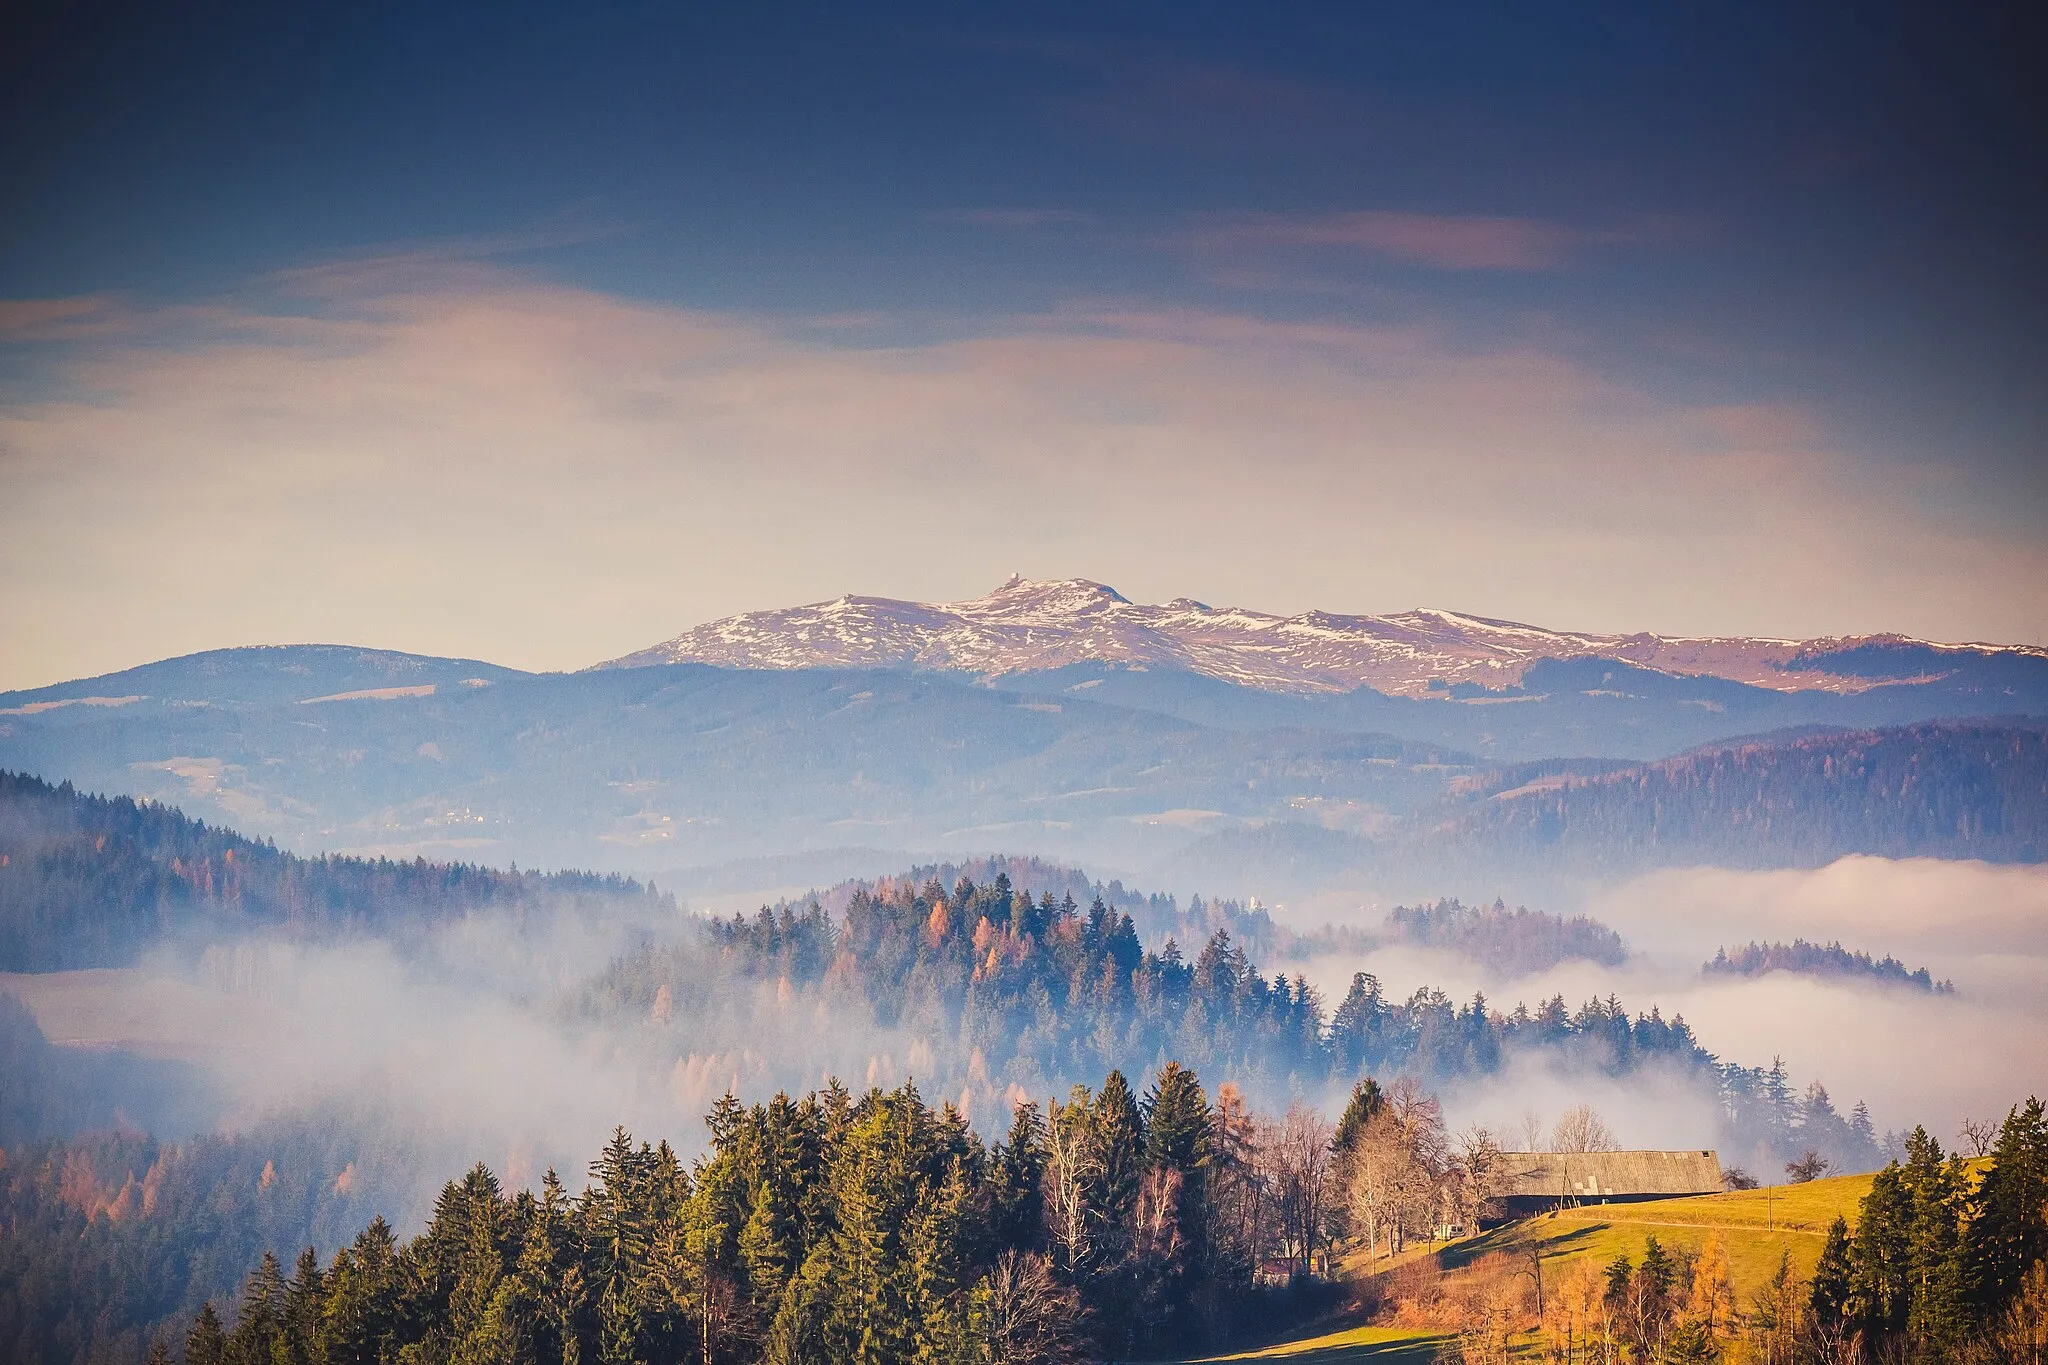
[{"xmin": 1300, "ymin": 857, "xmax": 2048, "ymax": 1146}]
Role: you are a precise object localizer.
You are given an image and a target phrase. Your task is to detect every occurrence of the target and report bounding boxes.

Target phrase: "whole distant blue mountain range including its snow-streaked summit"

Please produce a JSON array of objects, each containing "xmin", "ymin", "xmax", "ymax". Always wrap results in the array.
[{"xmin": 0, "ymin": 579, "xmax": 2048, "ymax": 900}]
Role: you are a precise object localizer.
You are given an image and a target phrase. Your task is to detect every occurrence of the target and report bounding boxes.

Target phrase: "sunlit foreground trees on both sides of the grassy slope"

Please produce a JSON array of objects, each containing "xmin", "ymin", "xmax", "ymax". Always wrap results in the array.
[{"xmin": 51, "ymin": 1064, "xmax": 2048, "ymax": 1365}]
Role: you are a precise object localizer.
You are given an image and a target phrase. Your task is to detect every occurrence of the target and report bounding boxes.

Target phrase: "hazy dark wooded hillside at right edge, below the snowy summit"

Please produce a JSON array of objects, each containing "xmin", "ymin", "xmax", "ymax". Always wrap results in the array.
[{"xmin": 1176, "ymin": 718, "xmax": 2048, "ymax": 898}]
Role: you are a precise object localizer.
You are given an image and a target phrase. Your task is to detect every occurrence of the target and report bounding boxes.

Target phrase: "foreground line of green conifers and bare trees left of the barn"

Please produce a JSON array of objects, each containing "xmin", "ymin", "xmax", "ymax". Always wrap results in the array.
[{"xmin": 182, "ymin": 1062, "xmax": 1409, "ymax": 1365}]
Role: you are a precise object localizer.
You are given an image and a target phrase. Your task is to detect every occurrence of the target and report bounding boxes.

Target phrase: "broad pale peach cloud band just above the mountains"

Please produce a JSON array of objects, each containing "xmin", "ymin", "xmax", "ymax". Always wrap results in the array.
[{"xmin": 0, "ymin": 263, "xmax": 2048, "ymax": 686}]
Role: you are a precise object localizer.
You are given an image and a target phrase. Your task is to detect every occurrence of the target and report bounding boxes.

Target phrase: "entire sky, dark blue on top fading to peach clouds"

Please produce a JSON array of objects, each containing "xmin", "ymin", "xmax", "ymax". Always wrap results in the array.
[{"xmin": 0, "ymin": 0, "xmax": 2048, "ymax": 688}]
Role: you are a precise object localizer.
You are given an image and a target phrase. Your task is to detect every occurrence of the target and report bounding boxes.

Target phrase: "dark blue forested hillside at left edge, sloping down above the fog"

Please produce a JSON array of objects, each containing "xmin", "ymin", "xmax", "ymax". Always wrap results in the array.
[{"xmin": 0, "ymin": 772, "xmax": 653, "ymax": 972}]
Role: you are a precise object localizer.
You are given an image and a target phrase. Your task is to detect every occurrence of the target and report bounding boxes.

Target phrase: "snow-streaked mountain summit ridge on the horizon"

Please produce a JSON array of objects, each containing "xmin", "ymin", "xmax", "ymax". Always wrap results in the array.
[{"xmin": 598, "ymin": 577, "xmax": 2048, "ymax": 696}]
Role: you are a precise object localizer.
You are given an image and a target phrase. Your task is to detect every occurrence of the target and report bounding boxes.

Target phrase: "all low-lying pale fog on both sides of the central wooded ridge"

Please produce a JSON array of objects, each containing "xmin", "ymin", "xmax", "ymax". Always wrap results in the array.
[{"xmin": 0, "ymin": 857, "xmax": 2048, "ymax": 1227}]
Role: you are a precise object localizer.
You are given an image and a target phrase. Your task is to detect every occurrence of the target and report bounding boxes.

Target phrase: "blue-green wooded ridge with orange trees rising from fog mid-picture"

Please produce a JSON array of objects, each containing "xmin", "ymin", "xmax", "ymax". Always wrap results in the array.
[{"xmin": 578, "ymin": 874, "xmax": 1878, "ymax": 1169}]
